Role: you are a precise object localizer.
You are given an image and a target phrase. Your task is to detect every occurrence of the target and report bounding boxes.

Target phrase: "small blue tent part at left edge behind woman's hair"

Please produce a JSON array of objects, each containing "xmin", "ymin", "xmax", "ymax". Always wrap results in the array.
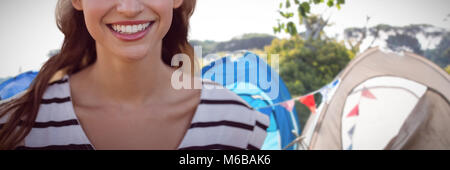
[{"xmin": 0, "ymin": 71, "xmax": 38, "ymax": 100}]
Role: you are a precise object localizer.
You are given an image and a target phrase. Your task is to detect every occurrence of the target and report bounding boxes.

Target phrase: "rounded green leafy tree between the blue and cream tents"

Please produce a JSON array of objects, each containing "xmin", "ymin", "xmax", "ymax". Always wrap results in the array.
[{"xmin": 265, "ymin": 35, "xmax": 354, "ymax": 125}]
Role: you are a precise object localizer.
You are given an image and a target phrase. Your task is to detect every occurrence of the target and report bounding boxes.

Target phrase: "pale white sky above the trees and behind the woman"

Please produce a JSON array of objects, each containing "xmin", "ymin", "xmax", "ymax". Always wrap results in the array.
[{"xmin": 0, "ymin": 0, "xmax": 450, "ymax": 77}]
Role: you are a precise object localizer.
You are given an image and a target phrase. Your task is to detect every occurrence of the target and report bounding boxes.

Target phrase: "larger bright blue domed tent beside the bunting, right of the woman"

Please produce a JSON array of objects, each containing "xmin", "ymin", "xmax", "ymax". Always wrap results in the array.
[{"xmin": 202, "ymin": 52, "xmax": 300, "ymax": 150}]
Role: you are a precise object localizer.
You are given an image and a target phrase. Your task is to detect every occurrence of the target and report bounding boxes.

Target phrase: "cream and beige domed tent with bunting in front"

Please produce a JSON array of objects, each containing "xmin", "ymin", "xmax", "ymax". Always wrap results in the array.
[{"xmin": 302, "ymin": 48, "xmax": 450, "ymax": 150}]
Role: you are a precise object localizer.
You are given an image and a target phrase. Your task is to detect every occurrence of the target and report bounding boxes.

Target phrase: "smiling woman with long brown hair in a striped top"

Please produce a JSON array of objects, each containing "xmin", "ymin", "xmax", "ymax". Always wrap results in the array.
[{"xmin": 0, "ymin": 0, "xmax": 268, "ymax": 149}]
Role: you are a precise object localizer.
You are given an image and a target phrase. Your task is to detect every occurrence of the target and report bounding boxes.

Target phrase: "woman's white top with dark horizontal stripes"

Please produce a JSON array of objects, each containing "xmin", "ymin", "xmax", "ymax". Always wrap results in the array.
[{"xmin": 0, "ymin": 75, "xmax": 269, "ymax": 150}]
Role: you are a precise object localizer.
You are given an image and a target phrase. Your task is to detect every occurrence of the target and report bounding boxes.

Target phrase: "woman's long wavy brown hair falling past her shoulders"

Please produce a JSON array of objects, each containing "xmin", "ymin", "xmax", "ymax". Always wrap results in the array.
[{"xmin": 0, "ymin": 0, "xmax": 196, "ymax": 149}]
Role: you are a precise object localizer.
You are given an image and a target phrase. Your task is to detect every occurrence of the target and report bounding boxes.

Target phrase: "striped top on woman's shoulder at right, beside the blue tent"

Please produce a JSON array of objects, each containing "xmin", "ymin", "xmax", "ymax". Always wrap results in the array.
[{"xmin": 178, "ymin": 81, "xmax": 269, "ymax": 150}]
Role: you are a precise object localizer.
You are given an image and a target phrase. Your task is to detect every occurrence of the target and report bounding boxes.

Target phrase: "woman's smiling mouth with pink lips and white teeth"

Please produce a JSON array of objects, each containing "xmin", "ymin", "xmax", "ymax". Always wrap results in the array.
[{"xmin": 107, "ymin": 21, "xmax": 154, "ymax": 41}]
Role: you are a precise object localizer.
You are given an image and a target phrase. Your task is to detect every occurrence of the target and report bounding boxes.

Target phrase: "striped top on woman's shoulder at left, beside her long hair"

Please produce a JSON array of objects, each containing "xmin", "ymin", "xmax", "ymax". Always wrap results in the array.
[{"xmin": 14, "ymin": 76, "xmax": 89, "ymax": 149}]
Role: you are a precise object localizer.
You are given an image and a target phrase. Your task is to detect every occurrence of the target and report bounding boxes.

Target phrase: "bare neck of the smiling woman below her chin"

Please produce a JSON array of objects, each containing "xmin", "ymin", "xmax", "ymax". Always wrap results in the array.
[{"xmin": 90, "ymin": 41, "xmax": 173, "ymax": 105}]
